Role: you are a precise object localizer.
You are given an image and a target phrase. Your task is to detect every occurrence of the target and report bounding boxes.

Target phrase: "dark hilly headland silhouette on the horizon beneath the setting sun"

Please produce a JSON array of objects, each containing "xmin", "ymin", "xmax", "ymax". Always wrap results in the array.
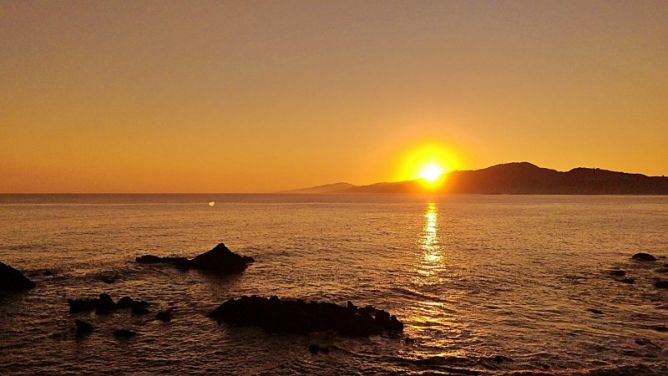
[{"xmin": 292, "ymin": 162, "xmax": 668, "ymax": 195}]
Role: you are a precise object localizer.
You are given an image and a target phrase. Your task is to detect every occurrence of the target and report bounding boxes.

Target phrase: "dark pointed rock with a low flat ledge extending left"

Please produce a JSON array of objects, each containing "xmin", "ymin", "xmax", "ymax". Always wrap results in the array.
[{"xmin": 135, "ymin": 243, "xmax": 254, "ymax": 274}]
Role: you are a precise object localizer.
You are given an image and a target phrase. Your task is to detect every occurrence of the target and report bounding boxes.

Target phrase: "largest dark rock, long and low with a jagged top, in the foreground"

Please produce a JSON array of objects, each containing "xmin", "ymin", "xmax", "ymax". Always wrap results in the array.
[{"xmin": 209, "ymin": 296, "xmax": 404, "ymax": 337}]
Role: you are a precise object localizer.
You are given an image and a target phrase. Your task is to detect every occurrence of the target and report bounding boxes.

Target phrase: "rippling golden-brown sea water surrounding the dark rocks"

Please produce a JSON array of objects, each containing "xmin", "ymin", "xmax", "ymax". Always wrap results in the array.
[{"xmin": 0, "ymin": 194, "xmax": 668, "ymax": 375}]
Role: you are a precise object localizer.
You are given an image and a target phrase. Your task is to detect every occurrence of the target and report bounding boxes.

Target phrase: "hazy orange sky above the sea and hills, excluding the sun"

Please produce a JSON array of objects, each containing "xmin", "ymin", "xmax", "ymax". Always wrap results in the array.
[{"xmin": 0, "ymin": 0, "xmax": 668, "ymax": 192}]
